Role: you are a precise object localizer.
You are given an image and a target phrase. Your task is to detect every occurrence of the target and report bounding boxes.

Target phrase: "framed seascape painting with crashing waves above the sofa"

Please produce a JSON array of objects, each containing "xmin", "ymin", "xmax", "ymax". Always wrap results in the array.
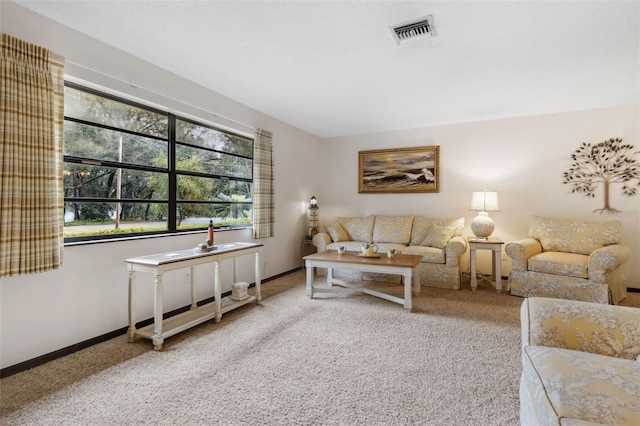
[{"xmin": 358, "ymin": 146, "xmax": 440, "ymax": 194}]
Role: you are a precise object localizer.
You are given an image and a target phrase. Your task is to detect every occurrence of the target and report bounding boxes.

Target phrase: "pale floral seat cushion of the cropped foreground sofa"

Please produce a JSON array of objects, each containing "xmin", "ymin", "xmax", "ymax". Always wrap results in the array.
[{"xmin": 521, "ymin": 346, "xmax": 640, "ymax": 425}]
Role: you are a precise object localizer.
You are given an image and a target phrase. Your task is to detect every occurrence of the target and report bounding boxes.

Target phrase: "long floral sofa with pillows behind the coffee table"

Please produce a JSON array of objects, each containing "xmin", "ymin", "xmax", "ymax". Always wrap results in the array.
[{"xmin": 313, "ymin": 215, "xmax": 467, "ymax": 290}]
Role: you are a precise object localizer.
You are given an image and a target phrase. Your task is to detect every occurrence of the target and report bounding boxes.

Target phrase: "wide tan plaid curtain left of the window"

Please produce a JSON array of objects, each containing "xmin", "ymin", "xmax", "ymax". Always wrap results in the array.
[{"xmin": 0, "ymin": 34, "xmax": 64, "ymax": 278}]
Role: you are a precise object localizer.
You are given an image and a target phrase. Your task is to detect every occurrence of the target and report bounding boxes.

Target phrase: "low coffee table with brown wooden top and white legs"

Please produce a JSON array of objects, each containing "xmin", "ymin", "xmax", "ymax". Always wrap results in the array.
[{"xmin": 304, "ymin": 250, "xmax": 422, "ymax": 310}]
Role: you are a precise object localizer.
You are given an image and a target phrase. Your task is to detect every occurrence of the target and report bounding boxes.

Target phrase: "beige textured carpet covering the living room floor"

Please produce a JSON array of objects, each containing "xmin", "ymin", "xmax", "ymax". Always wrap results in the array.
[{"xmin": 0, "ymin": 272, "xmax": 640, "ymax": 425}]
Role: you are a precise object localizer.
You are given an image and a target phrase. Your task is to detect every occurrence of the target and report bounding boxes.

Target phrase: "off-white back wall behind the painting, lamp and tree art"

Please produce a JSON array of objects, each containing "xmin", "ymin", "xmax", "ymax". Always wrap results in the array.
[{"xmin": 316, "ymin": 105, "xmax": 640, "ymax": 288}]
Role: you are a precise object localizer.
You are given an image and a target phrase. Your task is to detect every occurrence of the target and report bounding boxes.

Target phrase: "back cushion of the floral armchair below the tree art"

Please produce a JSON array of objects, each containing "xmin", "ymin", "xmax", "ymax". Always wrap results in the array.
[{"xmin": 529, "ymin": 216, "xmax": 622, "ymax": 255}]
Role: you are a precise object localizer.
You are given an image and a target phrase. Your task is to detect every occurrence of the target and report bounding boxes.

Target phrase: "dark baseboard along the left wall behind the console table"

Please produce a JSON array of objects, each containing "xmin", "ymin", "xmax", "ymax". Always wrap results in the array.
[{"xmin": 0, "ymin": 268, "xmax": 302, "ymax": 379}]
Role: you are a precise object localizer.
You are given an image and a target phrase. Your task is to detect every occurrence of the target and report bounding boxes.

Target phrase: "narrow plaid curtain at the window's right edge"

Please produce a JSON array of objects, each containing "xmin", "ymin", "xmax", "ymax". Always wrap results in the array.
[{"xmin": 253, "ymin": 129, "xmax": 276, "ymax": 239}]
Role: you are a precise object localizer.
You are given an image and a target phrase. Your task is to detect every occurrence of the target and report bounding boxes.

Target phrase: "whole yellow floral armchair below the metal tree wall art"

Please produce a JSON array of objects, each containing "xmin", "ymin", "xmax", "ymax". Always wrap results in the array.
[{"xmin": 505, "ymin": 216, "xmax": 631, "ymax": 304}]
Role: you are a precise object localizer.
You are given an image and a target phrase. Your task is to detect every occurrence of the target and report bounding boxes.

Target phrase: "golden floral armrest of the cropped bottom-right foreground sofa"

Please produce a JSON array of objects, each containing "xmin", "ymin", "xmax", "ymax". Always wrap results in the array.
[{"xmin": 520, "ymin": 297, "xmax": 640, "ymax": 360}]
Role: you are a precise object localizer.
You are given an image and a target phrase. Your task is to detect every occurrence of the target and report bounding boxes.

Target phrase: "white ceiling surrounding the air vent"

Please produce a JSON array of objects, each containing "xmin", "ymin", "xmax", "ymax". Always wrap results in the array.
[{"xmin": 15, "ymin": 0, "xmax": 640, "ymax": 138}]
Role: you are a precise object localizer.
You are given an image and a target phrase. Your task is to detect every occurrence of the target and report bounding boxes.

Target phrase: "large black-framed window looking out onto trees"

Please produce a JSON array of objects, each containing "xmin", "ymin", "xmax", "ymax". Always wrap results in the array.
[{"xmin": 64, "ymin": 83, "xmax": 253, "ymax": 241}]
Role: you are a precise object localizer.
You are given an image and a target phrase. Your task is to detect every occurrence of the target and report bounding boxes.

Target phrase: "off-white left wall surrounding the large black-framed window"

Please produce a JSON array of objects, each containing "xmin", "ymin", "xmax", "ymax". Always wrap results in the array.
[{"xmin": 0, "ymin": 1, "xmax": 321, "ymax": 368}]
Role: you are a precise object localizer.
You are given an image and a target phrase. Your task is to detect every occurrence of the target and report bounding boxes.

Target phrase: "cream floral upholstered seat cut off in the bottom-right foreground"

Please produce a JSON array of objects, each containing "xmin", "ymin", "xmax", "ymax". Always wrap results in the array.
[{"xmin": 520, "ymin": 297, "xmax": 640, "ymax": 426}]
